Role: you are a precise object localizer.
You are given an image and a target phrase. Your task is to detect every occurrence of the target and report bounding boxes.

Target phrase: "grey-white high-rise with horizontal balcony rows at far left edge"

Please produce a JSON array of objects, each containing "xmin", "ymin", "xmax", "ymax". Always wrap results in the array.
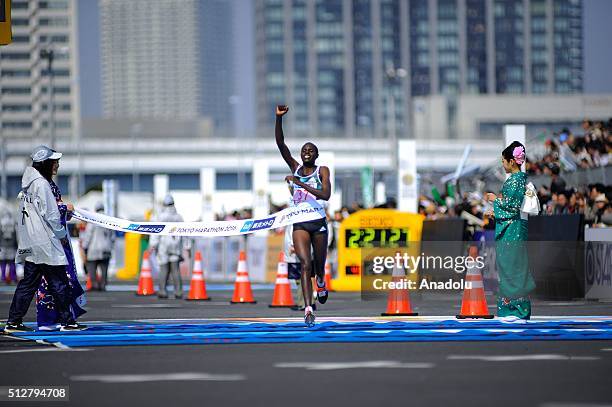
[{"xmin": 0, "ymin": 0, "xmax": 79, "ymax": 143}]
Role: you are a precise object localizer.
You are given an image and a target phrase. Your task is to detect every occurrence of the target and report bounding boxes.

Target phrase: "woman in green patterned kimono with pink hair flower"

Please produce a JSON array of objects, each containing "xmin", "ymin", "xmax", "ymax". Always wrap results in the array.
[{"xmin": 486, "ymin": 141, "xmax": 535, "ymax": 319}]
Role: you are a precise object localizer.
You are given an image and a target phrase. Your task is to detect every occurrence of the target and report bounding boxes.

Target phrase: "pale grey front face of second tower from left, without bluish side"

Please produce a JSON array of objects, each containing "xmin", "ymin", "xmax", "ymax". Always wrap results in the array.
[{"xmin": 99, "ymin": 0, "xmax": 200, "ymax": 118}]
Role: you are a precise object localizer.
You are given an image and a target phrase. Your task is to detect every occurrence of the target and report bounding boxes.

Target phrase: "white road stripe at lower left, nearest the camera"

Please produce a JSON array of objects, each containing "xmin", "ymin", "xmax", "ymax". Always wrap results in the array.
[{"xmin": 70, "ymin": 372, "xmax": 246, "ymax": 383}]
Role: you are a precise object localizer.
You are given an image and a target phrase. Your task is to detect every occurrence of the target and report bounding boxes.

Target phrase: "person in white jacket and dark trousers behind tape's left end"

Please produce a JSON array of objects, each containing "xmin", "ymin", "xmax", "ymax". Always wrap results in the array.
[{"xmin": 81, "ymin": 202, "xmax": 115, "ymax": 291}]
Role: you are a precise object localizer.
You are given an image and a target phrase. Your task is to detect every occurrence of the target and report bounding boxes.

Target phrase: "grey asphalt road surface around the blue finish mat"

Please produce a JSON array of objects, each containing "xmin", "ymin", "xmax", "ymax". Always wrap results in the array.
[{"xmin": 0, "ymin": 289, "xmax": 612, "ymax": 407}]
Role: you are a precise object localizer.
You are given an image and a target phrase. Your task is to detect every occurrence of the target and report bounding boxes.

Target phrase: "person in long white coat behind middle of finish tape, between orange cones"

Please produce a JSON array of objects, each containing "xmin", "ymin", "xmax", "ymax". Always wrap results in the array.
[{"xmin": 149, "ymin": 195, "xmax": 187, "ymax": 299}]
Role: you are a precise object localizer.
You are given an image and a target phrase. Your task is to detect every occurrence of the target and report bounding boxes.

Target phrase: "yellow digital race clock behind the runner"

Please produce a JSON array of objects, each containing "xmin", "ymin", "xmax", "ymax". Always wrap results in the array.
[{"xmin": 332, "ymin": 209, "xmax": 424, "ymax": 291}]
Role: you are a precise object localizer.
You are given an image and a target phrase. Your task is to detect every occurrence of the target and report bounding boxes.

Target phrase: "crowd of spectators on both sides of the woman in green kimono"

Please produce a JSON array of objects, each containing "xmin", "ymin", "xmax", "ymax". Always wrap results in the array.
[{"xmin": 419, "ymin": 118, "xmax": 612, "ymax": 229}]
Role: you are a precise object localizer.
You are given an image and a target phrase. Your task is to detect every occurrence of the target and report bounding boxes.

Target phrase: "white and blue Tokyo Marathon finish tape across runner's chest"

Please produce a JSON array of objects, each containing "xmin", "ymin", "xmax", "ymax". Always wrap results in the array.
[{"xmin": 72, "ymin": 200, "xmax": 325, "ymax": 237}]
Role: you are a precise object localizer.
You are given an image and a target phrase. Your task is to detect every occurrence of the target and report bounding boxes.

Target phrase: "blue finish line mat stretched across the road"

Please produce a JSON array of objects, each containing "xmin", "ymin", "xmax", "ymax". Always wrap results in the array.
[{"xmin": 9, "ymin": 317, "xmax": 612, "ymax": 347}]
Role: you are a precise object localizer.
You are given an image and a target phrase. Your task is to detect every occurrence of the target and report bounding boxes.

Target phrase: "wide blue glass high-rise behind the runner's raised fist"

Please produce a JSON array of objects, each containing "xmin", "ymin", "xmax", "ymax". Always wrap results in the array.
[{"xmin": 255, "ymin": 0, "xmax": 583, "ymax": 137}]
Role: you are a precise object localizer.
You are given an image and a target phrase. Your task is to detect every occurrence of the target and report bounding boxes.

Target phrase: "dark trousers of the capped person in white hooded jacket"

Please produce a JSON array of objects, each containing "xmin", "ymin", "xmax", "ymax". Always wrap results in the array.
[{"xmin": 8, "ymin": 261, "xmax": 74, "ymax": 324}]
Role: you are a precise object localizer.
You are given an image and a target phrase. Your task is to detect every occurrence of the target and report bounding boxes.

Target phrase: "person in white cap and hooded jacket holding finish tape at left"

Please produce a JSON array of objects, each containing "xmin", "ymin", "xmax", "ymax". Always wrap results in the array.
[{"xmin": 4, "ymin": 146, "xmax": 85, "ymax": 333}]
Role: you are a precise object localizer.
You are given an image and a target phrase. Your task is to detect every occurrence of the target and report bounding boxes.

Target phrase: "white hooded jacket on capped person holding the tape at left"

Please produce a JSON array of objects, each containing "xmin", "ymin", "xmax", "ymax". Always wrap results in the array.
[{"xmin": 15, "ymin": 167, "xmax": 68, "ymax": 266}]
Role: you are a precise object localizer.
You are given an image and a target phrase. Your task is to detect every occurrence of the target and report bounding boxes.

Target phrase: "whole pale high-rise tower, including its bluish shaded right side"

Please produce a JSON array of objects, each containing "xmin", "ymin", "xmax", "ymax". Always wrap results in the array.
[{"xmin": 100, "ymin": 0, "xmax": 235, "ymax": 129}]
